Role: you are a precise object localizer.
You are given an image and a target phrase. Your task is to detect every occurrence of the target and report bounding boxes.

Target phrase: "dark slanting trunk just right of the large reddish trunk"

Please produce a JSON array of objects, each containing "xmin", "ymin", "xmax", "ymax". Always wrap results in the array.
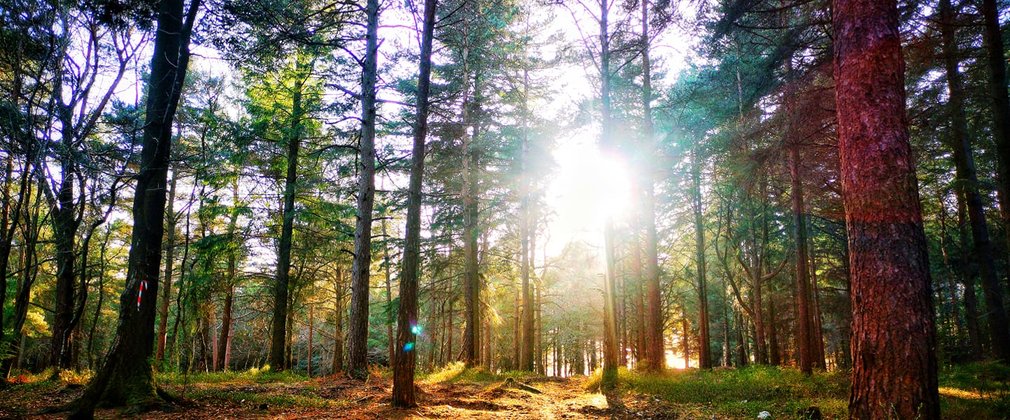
[{"xmin": 939, "ymin": 0, "xmax": 1010, "ymax": 361}]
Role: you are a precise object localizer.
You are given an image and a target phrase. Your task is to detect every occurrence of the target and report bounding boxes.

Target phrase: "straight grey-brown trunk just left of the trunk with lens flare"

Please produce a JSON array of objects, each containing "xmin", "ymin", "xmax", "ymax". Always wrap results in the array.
[{"xmin": 347, "ymin": 0, "xmax": 379, "ymax": 379}]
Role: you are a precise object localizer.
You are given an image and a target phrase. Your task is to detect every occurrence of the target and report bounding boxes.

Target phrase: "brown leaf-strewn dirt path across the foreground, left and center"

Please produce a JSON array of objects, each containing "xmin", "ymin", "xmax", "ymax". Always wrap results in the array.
[{"xmin": 0, "ymin": 378, "xmax": 675, "ymax": 419}]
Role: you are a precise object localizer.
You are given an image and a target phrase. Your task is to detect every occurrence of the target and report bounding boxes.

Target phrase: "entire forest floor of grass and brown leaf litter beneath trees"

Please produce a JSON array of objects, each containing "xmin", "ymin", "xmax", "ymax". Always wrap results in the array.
[{"xmin": 0, "ymin": 363, "xmax": 1010, "ymax": 419}]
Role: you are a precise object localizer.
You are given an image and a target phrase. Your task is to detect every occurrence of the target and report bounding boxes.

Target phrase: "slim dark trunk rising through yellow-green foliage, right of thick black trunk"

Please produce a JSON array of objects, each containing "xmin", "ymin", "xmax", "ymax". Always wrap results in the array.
[{"xmin": 270, "ymin": 63, "xmax": 304, "ymax": 372}]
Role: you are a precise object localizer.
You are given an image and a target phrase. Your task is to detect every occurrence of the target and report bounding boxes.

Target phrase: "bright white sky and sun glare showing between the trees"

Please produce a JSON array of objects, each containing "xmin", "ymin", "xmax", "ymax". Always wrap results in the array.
[{"xmin": 78, "ymin": 0, "xmax": 693, "ymax": 264}]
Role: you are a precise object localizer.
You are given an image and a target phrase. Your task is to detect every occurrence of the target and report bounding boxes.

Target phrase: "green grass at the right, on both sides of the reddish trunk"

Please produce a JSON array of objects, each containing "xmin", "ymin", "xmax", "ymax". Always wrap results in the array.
[{"xmin": 614, "ymin": 362, "xmax": 1010, "ymax": 419}]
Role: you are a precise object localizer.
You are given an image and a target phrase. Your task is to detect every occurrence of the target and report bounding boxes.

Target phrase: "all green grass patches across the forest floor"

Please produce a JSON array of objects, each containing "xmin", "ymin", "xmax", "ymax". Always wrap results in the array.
[{"xmin": 0, "ymin": 362, "xmax": 1010, "ymax": 420}]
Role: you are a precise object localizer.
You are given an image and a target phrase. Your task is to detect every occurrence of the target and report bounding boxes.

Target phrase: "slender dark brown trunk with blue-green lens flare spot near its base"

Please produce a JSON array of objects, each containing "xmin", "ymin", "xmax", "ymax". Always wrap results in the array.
[{"xmin": 393, "ymin": 0, "xmax": 436, "ymax": 407}]
